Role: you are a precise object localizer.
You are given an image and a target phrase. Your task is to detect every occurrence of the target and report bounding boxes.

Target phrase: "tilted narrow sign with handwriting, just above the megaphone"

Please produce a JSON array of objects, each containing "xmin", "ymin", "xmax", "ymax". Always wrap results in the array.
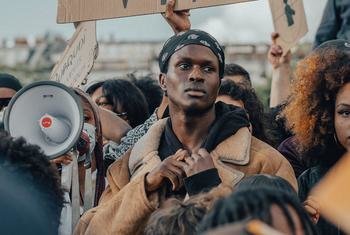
[{"xmin": 50, "ymin": 21, "xmax": 97, "ymax": 87}]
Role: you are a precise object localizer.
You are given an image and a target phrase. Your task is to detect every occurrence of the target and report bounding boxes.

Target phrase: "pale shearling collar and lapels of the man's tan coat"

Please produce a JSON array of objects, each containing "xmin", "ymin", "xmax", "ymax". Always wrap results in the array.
[{"xmin": 129, "ymin": 119, "xmax": 252, "ymax": 185}]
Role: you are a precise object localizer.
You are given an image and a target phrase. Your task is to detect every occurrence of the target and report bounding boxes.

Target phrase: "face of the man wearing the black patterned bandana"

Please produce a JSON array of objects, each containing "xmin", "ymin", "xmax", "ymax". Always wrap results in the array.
[{"xmin": 160, "ymin": 45, "xmax": 220, "ymax": 113}]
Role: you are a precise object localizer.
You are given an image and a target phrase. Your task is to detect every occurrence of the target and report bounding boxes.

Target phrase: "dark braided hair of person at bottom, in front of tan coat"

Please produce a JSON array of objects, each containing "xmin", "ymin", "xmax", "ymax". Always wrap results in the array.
[{"xmin": 198, "ymin": 187, "xmax": 317, "ymax": 235}]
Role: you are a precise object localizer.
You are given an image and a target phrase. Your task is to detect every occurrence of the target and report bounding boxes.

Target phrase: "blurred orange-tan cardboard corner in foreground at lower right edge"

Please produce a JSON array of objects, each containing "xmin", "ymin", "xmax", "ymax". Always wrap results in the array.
[{"xmin": 310, "ymin": 154, "xmax": 350, "ymax": 234}]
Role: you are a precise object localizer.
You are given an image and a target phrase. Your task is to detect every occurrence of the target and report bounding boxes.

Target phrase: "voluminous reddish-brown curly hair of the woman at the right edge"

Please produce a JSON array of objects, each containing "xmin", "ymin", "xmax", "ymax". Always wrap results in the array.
[{"xmin": 282, "ymin": 40, "xmax": 350, "ymax": 160}]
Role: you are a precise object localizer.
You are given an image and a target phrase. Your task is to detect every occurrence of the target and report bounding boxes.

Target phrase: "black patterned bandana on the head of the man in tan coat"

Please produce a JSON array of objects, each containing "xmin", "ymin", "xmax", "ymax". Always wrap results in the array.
[{"xmin": 158, "ymin": 29, "xmax": 225, "ymax": 78}]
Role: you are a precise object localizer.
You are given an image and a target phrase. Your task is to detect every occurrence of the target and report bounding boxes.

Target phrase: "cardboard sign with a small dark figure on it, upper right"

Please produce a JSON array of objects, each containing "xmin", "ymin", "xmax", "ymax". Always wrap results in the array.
[{"xmin": 269, "ymin": 0, "xmax": 308, "ymax": 54}]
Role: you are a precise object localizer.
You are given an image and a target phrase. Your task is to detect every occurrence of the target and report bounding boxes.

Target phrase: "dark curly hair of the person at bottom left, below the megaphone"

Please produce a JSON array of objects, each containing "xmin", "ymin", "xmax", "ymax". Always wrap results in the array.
[{"xmin": 0, "ymin": 132, "xmax": 64, "ymax": 234}]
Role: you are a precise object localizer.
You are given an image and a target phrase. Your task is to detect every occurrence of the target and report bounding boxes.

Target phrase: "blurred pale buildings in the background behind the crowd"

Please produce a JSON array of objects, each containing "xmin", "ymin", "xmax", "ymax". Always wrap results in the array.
[{"xmin": 0, "ymin": 34, "xmax": 311, "ymax": 85}]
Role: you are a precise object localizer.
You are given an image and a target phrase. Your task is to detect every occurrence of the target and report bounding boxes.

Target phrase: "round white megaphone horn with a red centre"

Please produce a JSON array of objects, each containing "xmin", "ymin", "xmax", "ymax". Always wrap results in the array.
[{"xmin": 4, "ymin": 81, "xmax": 84, "ymax": 159}]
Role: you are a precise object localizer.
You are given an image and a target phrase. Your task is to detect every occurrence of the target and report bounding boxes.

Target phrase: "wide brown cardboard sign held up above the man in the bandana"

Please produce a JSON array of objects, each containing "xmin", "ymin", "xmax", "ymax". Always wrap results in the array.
[{"xmin": 57, "ymin": 0, "xmax": 255, "ymax": 23}]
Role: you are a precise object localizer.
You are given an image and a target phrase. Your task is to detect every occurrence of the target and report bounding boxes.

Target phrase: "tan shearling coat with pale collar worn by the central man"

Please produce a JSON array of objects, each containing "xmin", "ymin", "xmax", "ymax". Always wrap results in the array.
[{"xmin": 74, "ymin": 119, "xmax": 297, "ymax": 235}]
